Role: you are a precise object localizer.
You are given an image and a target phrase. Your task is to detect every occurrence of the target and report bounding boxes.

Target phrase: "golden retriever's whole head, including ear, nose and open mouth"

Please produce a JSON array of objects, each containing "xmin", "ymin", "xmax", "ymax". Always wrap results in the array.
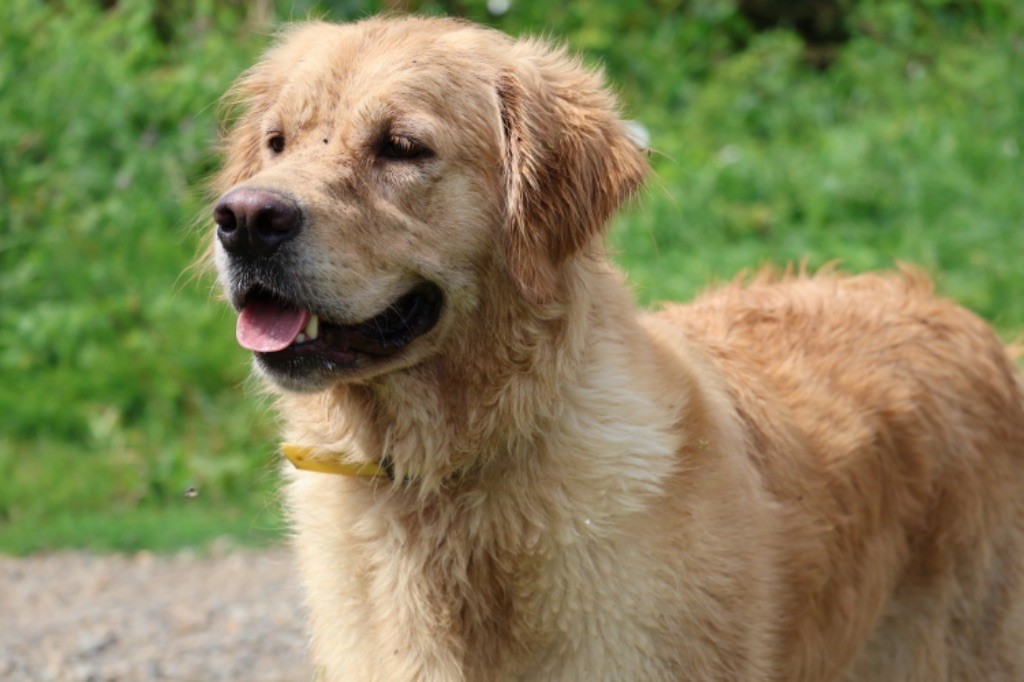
[{"xmin": 213, "ymin": 18, "xmax": 646, "ymax": 391}]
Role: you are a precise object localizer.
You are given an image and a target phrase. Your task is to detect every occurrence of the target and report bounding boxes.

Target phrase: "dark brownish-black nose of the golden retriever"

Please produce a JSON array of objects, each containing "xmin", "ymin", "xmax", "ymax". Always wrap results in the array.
[{"xmin": 213, "ymin": 187, "xmax": 302, "ymax": 256}]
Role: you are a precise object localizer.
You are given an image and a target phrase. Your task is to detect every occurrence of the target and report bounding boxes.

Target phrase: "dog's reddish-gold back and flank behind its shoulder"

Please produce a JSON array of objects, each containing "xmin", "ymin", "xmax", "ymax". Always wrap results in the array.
[{"xmin": 658, "ymin": 273, "xmax": 1024, "ymax": 680}]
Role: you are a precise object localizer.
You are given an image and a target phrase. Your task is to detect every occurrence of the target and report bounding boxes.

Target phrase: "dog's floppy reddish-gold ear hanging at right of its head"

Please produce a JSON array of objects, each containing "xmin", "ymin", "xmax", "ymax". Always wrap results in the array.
[{"xmin": 498, "ymin": 42, "xmax": 647, "ymax": 303}]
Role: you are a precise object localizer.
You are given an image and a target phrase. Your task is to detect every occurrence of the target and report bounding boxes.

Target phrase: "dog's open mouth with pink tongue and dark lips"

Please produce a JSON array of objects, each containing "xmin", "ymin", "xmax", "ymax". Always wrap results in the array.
[{"xmin": 236, "ymin": 283, "xmax": 442, "ymax": 367}]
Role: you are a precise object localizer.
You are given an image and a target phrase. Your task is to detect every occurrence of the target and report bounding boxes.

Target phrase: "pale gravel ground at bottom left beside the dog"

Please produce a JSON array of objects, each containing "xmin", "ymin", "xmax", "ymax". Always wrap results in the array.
[{"xmin": 0, "ymin": 549, "xmax": 312, "ymax": 682}]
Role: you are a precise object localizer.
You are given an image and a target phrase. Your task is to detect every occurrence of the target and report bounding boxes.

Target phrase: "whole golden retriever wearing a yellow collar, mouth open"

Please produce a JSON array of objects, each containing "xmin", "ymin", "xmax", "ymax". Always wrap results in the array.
[{"xmin": 212, "ymin": 17, "xmax": 1024, "ymax": 682}]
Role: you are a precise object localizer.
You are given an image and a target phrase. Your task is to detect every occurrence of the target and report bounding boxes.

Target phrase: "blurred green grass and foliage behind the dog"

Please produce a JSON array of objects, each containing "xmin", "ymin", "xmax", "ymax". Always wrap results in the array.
[{"xmin": 0, "ymin": 0, "xmax": 1024, "ymax": 553}]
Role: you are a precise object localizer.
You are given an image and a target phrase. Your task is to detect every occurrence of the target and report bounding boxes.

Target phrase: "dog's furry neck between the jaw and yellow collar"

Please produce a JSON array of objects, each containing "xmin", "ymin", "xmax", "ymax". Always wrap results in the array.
[{"xmin": 283, "ymin": 260, "xmax": 671, "ymax": 494}]
